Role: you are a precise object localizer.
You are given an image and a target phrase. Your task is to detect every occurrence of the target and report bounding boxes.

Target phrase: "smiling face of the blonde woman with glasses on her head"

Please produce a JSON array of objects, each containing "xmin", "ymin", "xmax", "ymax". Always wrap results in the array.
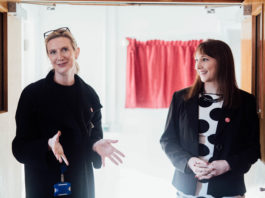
[{"xmin": 47, "ymin": 37, "xmax": 79, "ymax": 77}]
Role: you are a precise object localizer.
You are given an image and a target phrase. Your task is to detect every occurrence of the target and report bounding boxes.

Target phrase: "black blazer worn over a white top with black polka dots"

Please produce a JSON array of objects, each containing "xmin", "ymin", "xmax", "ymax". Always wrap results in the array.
[{"xmin": 160, "ymin": 88, "xmax": 260, "ymax": 197}]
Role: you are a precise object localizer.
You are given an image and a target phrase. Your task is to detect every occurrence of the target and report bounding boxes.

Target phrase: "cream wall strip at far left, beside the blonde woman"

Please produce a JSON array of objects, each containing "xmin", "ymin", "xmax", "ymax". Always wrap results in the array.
[{"xmin": 0, "ymin": 16, "xmax": 23, "ymax": 198}]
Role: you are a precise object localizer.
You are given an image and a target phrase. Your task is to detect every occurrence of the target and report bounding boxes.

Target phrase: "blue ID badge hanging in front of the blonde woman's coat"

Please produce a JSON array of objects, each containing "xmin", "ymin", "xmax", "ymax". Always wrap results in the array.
[{"xmin": 53, "ymin": 164, "xmax": 71, "ymax": 197}]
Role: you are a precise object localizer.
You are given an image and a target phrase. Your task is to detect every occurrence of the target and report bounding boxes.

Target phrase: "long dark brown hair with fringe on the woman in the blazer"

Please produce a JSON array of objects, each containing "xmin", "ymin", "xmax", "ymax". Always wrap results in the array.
[{"xmin": 186, "ymin": 39, "xmax": 238, "ymax": 107}]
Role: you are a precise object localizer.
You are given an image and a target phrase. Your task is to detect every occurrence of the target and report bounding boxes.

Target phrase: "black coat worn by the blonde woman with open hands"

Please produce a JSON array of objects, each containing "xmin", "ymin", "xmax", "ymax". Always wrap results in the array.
[{"xmin": 12, "ymin": 71, "xmax": 103, "ymax": 198}]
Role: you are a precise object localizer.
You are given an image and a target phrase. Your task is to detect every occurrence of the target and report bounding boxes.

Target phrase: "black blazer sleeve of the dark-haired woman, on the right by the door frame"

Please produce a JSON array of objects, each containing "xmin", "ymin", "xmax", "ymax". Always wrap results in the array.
[{"xmin": 227, "ymin": 95, "xmax": 260, "ymax": 173}]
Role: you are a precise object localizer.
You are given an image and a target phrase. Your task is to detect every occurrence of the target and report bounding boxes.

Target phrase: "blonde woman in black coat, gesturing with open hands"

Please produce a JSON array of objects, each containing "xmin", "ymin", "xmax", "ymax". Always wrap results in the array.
[{"xmin": 12, "ymin": 28, "xmax": 124, "ymax": 198}]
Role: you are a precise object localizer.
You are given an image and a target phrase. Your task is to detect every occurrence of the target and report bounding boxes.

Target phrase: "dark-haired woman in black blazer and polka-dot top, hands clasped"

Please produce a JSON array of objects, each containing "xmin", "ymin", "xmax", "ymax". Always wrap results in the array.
[{"xmin": 160, "ymin": 39, "xmax": 260, "ymax": 198}]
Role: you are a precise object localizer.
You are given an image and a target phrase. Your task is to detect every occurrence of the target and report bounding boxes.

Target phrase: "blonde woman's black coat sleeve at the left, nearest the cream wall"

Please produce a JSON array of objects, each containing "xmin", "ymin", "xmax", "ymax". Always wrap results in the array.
[{"xmin": 12, "ymin": 86, "xmax": 49, "ymax": 168}]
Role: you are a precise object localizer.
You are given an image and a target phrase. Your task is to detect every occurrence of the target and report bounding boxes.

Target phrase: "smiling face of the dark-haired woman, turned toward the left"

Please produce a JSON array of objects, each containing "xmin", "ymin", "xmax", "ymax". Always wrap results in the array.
[{"xmin": 195, "ymin": 52, "xmax": 217, "ymax": 83}]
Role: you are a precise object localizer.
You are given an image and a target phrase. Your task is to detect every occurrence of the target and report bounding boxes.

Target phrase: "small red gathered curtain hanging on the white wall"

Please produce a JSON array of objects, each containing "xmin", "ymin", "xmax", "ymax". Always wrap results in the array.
[{"xmin": 125, "ymin": 38, "xmax": 202, "ymax": 108}]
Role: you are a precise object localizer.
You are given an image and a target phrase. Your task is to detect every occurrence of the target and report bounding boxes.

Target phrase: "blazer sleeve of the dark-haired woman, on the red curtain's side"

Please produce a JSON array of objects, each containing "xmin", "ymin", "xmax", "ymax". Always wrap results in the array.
[{"xmin": 160, "ymin": 93, "xmax": 192, "ymax": 173}]
